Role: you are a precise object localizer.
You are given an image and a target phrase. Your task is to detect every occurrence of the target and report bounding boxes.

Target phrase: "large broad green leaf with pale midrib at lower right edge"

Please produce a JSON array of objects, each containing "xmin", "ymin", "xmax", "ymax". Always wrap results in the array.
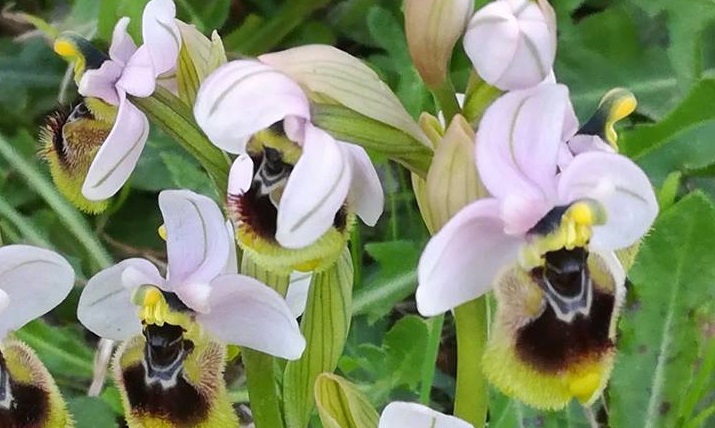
[{"xmin": 609, "ymin": 192, "xmax": 715, "ymax": 428}]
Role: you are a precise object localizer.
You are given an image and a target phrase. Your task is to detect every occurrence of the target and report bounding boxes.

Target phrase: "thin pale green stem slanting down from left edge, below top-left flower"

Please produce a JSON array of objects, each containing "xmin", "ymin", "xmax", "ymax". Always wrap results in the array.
[{"xmin": 0, "ymin": 136, "xmax": 113, "ymax": 270}]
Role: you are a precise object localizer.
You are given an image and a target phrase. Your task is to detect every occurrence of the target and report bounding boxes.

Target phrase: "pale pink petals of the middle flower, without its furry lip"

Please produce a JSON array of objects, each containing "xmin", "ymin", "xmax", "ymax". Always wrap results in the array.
[{"xmin": 194, "ymin": 60, "xmax": 383, "ymax": 248}]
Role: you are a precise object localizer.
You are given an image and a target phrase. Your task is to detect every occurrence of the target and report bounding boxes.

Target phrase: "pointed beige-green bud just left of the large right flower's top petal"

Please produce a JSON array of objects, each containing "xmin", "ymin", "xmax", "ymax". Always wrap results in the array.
[{"xmin": 427, "ymin": 115, "xmax": 487, "ymax": 229}]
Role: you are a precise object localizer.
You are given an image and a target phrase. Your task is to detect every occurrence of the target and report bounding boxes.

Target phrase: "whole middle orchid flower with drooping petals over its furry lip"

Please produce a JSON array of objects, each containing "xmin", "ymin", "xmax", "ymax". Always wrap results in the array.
[{"xmin": 194, "ymin": 60, "xmax": 383, "ymax": 271}]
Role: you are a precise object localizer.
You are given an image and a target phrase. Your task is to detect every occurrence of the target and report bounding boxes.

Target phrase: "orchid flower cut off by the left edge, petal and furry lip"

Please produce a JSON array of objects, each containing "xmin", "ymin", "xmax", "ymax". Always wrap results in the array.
[{"xmin": 0, "ymin": 245, "xmax": 74, "ymax": 427}]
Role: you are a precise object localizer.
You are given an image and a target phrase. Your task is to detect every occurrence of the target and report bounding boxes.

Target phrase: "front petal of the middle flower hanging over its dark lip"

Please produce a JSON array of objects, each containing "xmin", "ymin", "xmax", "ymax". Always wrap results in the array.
[{"xmin": 276, "ymin": 124, "xmax": 352, "ymax": 248}]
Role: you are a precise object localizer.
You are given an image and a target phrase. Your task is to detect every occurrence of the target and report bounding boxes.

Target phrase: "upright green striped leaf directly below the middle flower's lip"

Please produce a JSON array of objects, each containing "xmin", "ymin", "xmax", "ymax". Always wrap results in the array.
[{"xmin": 284, "ymin": 249, "xmax": 353, "ymax": 428}]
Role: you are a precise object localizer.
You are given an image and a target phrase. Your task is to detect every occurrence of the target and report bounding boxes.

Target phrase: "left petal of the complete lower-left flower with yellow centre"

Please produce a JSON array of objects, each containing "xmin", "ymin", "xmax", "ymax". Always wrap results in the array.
[{"xmin": 77, "ymin": 259, "xmax": 164, "ymax": 340}]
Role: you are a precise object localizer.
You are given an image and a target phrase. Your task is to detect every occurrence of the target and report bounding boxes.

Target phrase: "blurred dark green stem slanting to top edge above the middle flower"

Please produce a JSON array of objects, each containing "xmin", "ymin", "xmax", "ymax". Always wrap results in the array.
[{"xmin": 227, "ymin": 0, "xmax": 330, "ymax": 56}]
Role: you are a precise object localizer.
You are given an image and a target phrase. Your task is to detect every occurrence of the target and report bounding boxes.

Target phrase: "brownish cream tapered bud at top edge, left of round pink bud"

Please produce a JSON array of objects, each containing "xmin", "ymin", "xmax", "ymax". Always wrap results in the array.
[{"xmin": 404, "ymin": 0, "xmax": 474, "ymax": 88}]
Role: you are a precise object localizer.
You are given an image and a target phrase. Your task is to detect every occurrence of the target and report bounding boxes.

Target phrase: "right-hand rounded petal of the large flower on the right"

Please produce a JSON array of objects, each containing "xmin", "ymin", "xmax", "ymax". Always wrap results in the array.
[{"xmin": 559, "ymin": 151, "xmax": 658, "ymax": 250}]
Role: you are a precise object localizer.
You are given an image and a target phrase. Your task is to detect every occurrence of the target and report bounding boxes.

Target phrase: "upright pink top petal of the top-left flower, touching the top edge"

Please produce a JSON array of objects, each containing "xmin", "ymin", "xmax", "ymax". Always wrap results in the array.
[{"xmin": 142, "ymin": 0, "xmax": 181, "ymax": 77}]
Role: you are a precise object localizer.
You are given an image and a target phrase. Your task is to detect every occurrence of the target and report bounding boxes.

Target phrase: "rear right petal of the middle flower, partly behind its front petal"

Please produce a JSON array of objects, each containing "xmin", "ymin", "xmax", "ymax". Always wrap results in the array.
[{"xmin": 339, "ymin": 142, "xmax": 385, "ymax": 226}]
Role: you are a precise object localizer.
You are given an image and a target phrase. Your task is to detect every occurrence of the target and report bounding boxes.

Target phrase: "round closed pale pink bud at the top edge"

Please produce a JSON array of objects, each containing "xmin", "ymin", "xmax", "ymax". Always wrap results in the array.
[{"xmin": 464, "ymin": 0, "xmax": 556, "ymax": 90}]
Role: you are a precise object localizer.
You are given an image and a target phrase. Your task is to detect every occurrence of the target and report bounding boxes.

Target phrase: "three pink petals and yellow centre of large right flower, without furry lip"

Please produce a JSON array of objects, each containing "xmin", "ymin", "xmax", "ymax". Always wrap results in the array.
[{"xmin": 417, "ymin": 84, "xmax": 658, "ymax": 316}]
